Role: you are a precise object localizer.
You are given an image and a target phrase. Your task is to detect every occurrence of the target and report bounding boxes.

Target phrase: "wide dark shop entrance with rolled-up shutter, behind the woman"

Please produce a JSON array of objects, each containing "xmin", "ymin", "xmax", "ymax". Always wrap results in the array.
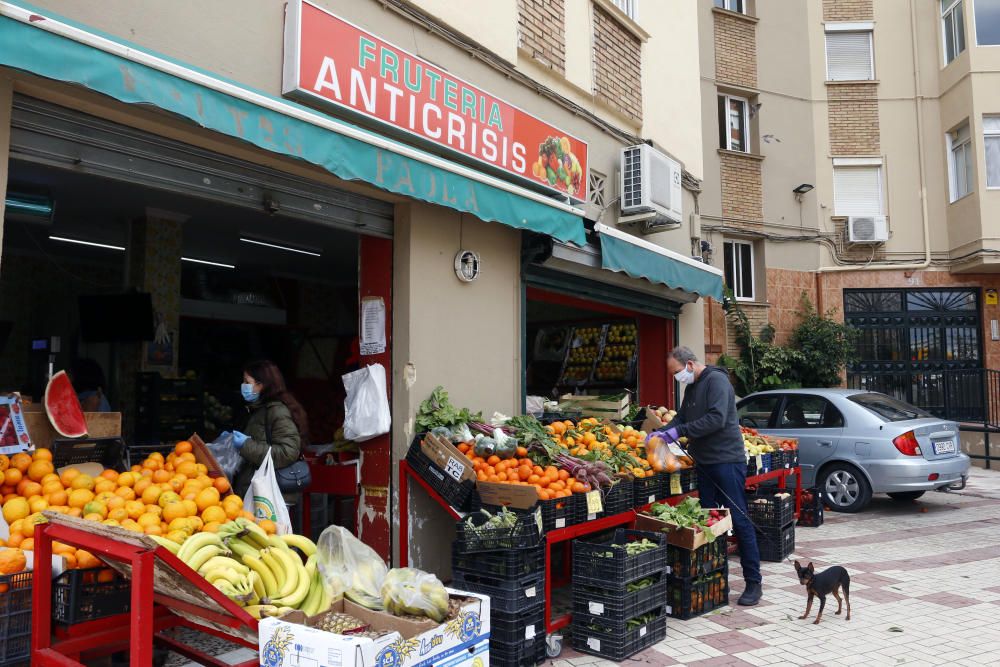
[{"xmin": 0, "ymin": 98, "xmax": 393, "ymax": 556}]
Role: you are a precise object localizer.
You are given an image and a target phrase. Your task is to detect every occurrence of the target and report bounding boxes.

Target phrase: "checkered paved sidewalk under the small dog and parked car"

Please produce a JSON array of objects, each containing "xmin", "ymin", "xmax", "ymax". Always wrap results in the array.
[{"xmin": 548, "ymin": 468, "xmax": 1000, "ymax": 667}]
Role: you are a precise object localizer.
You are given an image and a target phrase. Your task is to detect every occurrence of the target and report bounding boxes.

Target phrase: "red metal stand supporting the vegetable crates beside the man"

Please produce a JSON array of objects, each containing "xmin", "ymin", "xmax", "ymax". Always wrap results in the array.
[{"xmin": 399, "ymin": 461, "xmax": 802, "ymax": 634}]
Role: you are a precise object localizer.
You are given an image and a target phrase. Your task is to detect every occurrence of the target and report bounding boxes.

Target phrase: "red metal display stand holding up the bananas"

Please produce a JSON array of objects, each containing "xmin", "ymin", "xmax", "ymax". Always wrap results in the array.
[{"xmin": 31, "ymin": 523, "xmax": 259, "ymax": 667}]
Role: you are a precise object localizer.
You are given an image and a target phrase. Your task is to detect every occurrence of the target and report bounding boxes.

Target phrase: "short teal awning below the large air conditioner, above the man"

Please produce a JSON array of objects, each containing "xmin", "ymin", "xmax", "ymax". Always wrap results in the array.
[{"xmin": 594, "ymin": 224, "xmax": 723, "ymax": 301}]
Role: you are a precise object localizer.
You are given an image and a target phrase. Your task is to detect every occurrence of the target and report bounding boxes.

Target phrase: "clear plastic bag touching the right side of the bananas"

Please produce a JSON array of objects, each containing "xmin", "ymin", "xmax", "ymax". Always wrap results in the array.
[{"xmin": 316, "ymin": 526, "xmax": 388, "ymax": 609}]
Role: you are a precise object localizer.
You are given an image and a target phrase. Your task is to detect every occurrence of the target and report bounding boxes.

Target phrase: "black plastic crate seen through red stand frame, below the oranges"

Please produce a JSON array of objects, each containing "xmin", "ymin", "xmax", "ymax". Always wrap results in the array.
[{"xmin": 52, "ymin": 567, "xmax": 132, "ymax": 625}]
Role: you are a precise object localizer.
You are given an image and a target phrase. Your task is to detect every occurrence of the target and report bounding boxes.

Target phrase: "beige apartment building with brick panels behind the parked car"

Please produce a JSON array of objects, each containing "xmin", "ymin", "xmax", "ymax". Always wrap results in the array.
[{"xmin": 695, "ymin": 0, "xmax": 1000, "ymax": 417}]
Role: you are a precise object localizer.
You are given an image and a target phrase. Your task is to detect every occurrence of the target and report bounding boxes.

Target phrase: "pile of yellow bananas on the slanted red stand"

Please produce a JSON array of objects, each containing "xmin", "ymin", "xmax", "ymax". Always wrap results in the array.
[{"xmin": 150, "ymin": 517, "xmax": 332, "ymax": 619}]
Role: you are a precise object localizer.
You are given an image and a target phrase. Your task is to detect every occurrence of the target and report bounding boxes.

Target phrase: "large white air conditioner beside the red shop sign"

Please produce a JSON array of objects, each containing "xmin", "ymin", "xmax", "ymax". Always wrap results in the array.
[{"xmin": 619, "ymin": 144, "xmax": 683, "ymax": 227}]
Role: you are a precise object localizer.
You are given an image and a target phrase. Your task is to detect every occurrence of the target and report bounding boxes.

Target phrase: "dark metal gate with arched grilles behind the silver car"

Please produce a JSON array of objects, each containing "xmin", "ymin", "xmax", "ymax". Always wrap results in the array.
[{"xmin": 844, "ymin": 289, "xmax": 983, "ymax": 420}]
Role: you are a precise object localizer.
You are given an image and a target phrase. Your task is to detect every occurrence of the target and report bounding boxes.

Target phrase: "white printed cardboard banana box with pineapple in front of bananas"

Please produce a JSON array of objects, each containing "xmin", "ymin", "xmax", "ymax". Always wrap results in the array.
[{"xmin": 258, "ymin": 589, "xmax": 490, "ymax": 667}]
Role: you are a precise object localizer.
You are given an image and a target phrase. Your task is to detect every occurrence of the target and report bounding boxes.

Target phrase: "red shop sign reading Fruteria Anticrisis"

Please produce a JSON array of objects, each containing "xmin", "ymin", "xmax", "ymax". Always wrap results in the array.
[{"xmin": 283, "ymin": 0, "xmax": 587, "ymax": 201}]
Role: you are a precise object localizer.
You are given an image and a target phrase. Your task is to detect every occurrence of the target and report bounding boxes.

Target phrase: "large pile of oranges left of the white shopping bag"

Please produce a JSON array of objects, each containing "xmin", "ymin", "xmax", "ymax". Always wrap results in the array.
[{"xmin": 0, "ymin": 440, "xmax": 253, "ymax": 568}]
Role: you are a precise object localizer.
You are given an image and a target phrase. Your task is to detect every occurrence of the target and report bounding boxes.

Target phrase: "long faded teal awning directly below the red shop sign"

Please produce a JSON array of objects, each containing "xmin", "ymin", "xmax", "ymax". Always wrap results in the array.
[{"xmin": 0, "ymin": 5, "xmax": 586, "ymax": 245}]
